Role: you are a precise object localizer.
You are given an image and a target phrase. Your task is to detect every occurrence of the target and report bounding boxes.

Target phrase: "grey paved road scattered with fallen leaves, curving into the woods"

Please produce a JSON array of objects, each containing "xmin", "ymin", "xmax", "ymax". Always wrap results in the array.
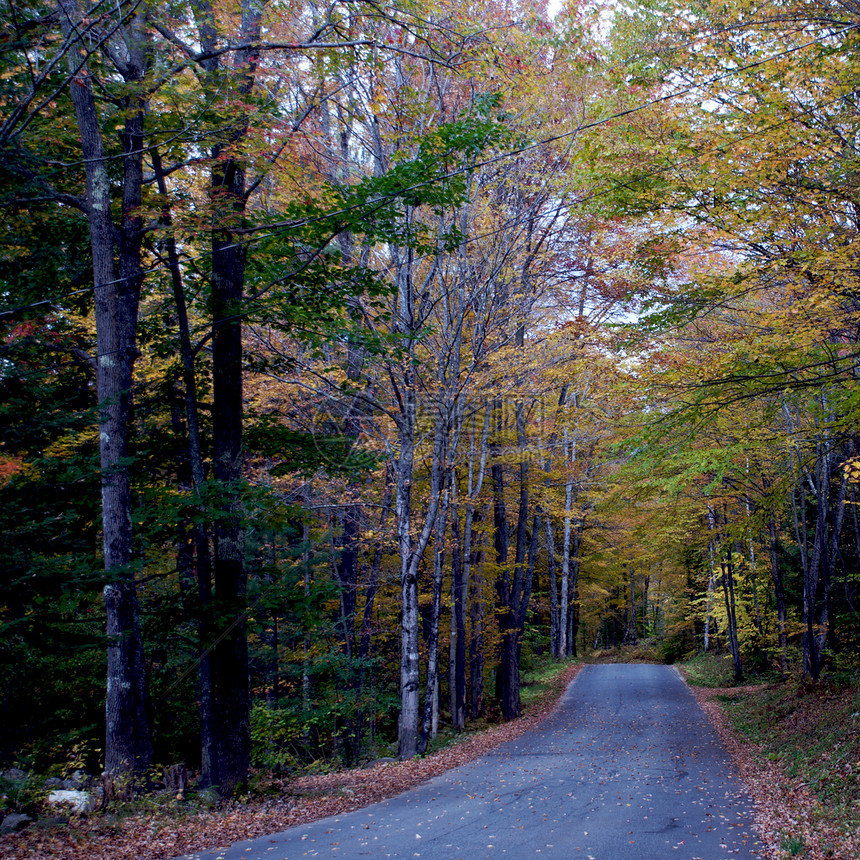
[{"xmin": 181, "ymin": 665, "xmax": 758, "ymax": 860}]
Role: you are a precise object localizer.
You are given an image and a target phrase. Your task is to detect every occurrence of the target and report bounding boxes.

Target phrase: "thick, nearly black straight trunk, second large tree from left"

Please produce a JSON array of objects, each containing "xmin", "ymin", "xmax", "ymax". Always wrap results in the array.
[{"xmin": 194, "ymin": 0, "xmax": 261, "ymax": 796}]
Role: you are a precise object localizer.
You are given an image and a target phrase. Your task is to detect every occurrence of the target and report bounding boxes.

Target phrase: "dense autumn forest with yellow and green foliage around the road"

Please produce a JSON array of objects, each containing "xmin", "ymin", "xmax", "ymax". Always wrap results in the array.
[{"xmin": 0, "ymin": 0, "xmax": 860, "ymax": 824}]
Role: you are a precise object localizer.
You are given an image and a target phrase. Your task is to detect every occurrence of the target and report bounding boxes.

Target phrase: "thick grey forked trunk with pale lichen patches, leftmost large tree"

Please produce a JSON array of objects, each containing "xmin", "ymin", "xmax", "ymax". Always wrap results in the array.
[{"xmin": 58, "ymin": 0, "xmax": 152, "ymax": 773}]
